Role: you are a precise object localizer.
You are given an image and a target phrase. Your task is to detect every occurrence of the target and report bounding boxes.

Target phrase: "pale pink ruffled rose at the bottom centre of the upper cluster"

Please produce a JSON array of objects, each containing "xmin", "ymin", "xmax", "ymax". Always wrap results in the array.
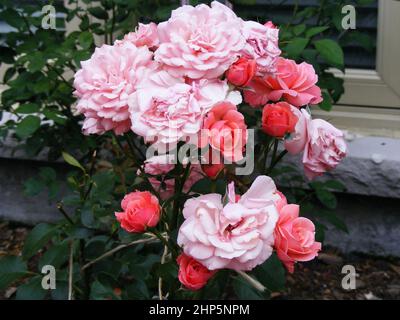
[{"xmin": 129, "ymin": 71, "xmax": 241, "ymax": 148}]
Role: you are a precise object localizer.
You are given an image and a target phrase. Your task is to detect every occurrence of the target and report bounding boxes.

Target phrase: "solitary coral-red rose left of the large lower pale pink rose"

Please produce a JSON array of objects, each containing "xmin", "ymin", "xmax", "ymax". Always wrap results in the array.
[{"xmin": 115, "ymin": 191, "xmax": 161, "ymax": 233}]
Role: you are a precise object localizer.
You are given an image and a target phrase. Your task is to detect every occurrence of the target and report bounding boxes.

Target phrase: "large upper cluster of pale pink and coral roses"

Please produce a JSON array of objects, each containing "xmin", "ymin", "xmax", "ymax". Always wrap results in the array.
[{"xmin": 74, "ymin": 2, "xmax": 346, "ymax": 178}]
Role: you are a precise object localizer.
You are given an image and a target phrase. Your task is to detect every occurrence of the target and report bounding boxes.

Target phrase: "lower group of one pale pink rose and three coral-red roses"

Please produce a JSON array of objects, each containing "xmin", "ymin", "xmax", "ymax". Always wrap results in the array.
[{"xmin": 115, "ymin": 176, "xmax": 321, "ymax": 290}]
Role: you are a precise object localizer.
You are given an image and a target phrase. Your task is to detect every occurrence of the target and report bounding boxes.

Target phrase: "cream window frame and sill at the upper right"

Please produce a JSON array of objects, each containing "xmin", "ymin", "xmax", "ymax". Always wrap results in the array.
[{"xmin": 313, "ymin": 0, "xmax": 400, "ymax": 137}]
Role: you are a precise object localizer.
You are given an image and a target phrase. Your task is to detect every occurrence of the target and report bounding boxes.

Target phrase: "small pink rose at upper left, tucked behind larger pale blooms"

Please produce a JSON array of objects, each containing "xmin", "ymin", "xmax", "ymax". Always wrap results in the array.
[{"xmin": 116, "ymin": 22, "xmax": 160, "ymax": 48}]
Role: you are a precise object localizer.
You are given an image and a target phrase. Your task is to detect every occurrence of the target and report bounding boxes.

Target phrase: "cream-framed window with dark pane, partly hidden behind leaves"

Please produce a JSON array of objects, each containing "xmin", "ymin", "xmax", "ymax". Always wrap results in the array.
[{"xmin": 235, "ymin": 0, "xmax": 400, "ymax": 134}]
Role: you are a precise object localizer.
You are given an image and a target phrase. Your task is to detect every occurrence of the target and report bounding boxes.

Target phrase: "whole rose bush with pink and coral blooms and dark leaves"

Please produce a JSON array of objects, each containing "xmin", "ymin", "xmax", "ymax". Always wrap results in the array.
[{"xmin": 0, "ymin": 0, "xmax": 366, "ymax": 299}]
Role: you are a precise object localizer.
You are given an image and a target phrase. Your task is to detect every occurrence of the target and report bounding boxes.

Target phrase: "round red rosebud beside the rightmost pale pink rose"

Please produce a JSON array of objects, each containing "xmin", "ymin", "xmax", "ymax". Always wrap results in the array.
[{"xmin": 262, "ymin": 102, "xmax": 298, "ymax": 138}]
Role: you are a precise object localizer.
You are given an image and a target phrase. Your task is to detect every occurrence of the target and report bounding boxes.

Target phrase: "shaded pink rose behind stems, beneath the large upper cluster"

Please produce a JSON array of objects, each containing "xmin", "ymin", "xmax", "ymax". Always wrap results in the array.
[{"xmin": 144, "ymin": 155, "xmax": 203, "ymax": 200}]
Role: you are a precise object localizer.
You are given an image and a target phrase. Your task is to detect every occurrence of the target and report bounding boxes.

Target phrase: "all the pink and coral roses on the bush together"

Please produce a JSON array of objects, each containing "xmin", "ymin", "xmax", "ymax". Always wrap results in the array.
[{"xmin": 74, "ymin": 1, "xmax": 346, "ymax": 290}]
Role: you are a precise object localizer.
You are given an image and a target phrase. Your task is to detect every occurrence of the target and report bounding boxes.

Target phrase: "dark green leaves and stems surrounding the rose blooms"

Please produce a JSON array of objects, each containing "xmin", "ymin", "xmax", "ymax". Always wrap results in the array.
[{"xmin": 0, "ymin": 0, "xmax": 358, "ymax": 299}]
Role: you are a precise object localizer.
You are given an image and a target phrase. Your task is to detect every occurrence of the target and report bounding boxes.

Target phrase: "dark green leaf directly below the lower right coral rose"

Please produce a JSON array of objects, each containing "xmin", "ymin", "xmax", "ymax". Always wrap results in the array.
[{"xmin": 254, "ymin": 254, "xmax": 285, "ymax": 291}]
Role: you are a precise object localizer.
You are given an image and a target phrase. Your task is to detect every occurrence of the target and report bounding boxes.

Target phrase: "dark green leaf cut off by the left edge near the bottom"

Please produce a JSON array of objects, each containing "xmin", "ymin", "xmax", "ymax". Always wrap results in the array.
[{"xmin": 0, "ymin": 256, "xmax": 27, "ymax": 290}]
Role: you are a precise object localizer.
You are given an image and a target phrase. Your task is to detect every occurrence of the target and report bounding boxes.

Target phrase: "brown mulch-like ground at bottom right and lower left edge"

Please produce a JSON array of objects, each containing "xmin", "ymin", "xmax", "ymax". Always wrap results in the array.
[{"xmin": 0, "ymin": 222, "xmax": 400, "ymax": 300}]
